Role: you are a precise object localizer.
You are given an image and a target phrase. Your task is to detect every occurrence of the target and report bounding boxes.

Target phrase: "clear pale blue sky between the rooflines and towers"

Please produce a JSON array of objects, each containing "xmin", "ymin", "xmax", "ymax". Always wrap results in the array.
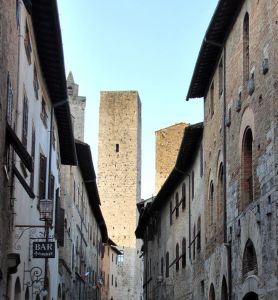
[{"xmin": 58, "ymin": 0, "xmax": 217, "ymax": 198}]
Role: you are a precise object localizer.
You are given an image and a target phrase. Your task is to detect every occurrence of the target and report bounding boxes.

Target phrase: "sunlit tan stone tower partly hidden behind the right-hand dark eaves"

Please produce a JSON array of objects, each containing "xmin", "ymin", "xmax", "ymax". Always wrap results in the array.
[{"xmin": 155, "ymin": 123, "xmax": 189, "ymax": 194}]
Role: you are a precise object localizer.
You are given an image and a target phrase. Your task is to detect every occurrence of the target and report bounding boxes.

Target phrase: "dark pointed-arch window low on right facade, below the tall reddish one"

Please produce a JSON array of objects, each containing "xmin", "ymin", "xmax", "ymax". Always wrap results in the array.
[{"xmin": 242, "ymin": 240, "xmax": 258, "ymax": 280}]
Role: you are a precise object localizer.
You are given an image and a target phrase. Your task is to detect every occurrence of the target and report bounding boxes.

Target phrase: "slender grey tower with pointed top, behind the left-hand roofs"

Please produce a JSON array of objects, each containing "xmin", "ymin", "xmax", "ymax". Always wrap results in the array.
[{"xmin": 67, "ymin": 72, "xmax": 86, "ymax": 141}]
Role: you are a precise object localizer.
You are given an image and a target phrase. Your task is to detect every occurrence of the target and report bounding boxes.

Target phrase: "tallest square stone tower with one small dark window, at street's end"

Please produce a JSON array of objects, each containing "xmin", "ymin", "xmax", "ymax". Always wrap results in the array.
[{"xmin": 98, "ymin": 91, "xmax": 141, "ymax": 300}]
